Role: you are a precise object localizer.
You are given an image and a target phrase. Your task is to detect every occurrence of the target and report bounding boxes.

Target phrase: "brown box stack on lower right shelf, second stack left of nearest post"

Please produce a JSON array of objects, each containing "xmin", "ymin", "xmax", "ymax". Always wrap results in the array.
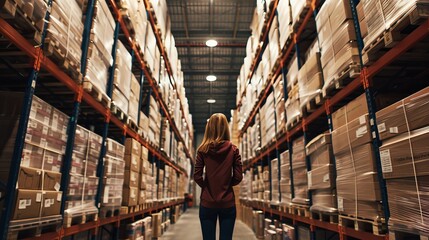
[{"xmin": 305, "ymin": 133, "xmax": 337, "ymax": 213}]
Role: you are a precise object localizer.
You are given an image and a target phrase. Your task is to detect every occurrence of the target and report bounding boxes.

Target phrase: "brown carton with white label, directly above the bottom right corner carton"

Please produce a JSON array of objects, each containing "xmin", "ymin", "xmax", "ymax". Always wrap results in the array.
[{"xmin": 380, "ymin": 127, "xmax": 429, "ymax": 179}]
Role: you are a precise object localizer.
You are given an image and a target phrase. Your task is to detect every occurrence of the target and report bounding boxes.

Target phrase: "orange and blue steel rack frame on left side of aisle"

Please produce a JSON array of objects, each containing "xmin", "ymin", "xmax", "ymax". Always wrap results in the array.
[{"xmin": 0, "ymin": 0, "xmax": 193, "ymax": 239}]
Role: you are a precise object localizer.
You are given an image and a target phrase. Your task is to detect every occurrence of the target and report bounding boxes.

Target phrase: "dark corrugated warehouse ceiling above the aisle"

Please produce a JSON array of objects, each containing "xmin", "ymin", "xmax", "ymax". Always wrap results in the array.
[{"xmin": 167, "ymin": 0, "xmax": 256, "ymax": 133}]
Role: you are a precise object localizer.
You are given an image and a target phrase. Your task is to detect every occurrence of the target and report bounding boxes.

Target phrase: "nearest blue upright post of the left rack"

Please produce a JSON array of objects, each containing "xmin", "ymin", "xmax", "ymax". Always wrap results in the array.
[{"xmin": 0, "ymin": 0, "xmax": 52, "ymax": 236}]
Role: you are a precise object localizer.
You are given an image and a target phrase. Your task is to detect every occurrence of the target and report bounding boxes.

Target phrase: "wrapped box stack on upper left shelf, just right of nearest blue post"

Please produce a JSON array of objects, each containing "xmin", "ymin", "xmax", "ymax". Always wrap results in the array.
[{"xmin": 44, "ymin": 0, "xmax": 83, "ymax": 81}]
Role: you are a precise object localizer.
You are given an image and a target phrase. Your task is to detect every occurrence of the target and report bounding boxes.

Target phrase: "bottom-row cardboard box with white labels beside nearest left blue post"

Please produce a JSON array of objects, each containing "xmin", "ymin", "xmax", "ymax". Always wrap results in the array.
[{"xmin": 12, "ymin": 189, "xmax": 43, "ymax": 220}]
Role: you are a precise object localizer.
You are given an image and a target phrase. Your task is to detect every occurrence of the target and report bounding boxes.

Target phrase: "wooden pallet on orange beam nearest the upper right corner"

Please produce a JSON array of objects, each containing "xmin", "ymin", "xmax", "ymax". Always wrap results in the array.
[{"xmin": 362, "ymin": 5, "xmax": 429, "ymax": 66}]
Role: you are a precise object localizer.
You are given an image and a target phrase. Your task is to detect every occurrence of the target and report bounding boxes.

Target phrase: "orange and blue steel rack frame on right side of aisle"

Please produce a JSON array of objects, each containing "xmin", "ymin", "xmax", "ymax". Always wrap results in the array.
[{"xmin": 237, "ymin": 0, "xmax": 429, "ymax": 239}]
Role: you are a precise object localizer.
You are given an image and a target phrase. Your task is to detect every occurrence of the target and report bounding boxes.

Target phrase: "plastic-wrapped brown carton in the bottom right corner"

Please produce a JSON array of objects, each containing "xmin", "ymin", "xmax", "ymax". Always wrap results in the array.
[{"xmin": 386, "ymin": 176, "xmax": 429, "ymax": 235}]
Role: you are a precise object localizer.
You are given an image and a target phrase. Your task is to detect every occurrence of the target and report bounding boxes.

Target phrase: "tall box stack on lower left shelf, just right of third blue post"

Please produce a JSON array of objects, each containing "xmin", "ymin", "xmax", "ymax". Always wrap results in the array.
[{"xmin": 100, "ymin": 138, "xmax": 125, "ymax": 218}]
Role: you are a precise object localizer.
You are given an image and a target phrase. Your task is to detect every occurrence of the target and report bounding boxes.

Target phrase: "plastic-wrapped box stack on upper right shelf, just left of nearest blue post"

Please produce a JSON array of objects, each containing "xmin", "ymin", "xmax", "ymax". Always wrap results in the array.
[{"xmin": 316, "ymin": 0, "xmax": 360, "ymax": 94}]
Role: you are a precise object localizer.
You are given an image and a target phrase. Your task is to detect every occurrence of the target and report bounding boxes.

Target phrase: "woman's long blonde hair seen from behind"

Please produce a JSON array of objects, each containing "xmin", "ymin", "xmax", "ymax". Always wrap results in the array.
[{"xmin": 198, "ymin": 113, "xmax": 231, "ymax": 153}]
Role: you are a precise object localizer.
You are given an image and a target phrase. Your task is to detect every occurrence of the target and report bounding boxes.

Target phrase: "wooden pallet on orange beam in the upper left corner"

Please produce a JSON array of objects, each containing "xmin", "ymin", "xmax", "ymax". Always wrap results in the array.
[{"xmin": 0, "ymin": 0, "xmax": 45, "ymax": 45}]
